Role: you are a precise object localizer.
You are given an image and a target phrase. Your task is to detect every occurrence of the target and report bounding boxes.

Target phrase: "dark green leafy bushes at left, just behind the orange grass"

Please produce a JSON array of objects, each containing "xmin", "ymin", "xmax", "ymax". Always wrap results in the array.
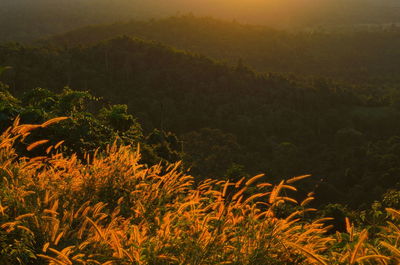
[{"xmin": 0, "ymin": 83, "xmax": 180, "ymax": 164}]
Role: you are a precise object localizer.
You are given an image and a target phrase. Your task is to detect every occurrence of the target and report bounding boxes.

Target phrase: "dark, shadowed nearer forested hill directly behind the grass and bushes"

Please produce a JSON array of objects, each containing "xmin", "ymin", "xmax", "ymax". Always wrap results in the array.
[{"xmin": 0, "ymin": 37, "xmax": 400, "ymax": 207}]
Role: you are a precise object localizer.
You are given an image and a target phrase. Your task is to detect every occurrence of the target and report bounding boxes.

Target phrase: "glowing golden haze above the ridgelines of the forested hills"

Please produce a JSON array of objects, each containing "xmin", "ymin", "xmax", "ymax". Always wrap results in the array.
[{"xmin": 0, "ymin": 0, "xmax": 400, "ymax": 41}]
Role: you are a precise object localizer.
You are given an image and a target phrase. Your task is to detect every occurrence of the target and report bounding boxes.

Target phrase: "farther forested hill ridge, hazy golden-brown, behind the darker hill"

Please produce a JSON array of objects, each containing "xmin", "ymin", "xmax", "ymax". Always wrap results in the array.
[{"xmin": 50, "ymin": 16, "xmax": 400, "ymax": 86}]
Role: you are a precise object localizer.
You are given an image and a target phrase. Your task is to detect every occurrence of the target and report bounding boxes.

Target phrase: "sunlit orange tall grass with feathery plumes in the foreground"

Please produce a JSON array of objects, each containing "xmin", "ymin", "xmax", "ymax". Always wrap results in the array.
[{"xmin": 0, "ymin": 118, "xmax": 400, "ymax": 265}]
